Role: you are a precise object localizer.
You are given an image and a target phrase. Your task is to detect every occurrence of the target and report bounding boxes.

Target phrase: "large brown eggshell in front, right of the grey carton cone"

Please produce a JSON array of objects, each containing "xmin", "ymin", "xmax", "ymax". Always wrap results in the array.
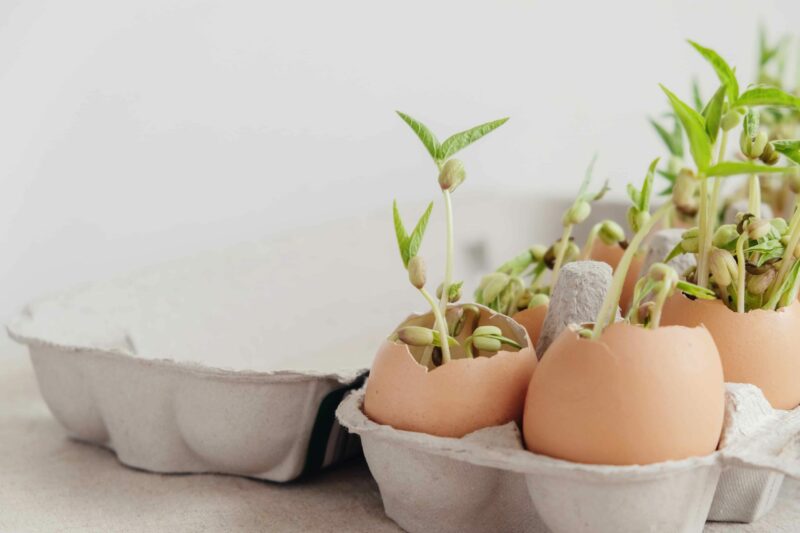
[{"xmin": 523, "ymin": 323, "xmax": 725, "ymax": 465}]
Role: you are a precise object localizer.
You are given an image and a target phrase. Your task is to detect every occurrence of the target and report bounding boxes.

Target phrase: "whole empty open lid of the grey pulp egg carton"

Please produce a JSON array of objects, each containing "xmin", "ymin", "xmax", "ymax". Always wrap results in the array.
[{"xmin": 8, "ymin": 191, "xmax": 580, "ymax": 481}]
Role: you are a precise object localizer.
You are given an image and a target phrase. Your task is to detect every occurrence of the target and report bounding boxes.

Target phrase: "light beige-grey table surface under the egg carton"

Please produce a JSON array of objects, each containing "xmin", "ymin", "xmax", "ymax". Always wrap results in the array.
[{"xmin": 0, "ymin": 333, "xmax": 800, "ymax": 533}]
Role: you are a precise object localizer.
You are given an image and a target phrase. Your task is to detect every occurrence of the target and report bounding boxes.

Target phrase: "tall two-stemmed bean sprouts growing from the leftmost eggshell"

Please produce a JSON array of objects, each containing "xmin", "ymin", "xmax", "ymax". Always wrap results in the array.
[{"xmin": 394, "ymin": 111, "xmax": 521, "ymax": 367}]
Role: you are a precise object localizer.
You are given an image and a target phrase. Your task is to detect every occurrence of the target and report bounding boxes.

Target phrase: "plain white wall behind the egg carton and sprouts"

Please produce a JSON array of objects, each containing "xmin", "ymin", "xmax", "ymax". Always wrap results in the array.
[{"xmin": 0, "ymin": 0, "xmax": 800, "ymax": 318}]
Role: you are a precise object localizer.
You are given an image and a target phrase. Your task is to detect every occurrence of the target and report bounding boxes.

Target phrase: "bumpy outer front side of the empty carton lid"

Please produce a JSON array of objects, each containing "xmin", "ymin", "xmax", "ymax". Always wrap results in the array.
[{"xmin": 9, "ymin": 306, "xmax": 364, "ymax": 481}]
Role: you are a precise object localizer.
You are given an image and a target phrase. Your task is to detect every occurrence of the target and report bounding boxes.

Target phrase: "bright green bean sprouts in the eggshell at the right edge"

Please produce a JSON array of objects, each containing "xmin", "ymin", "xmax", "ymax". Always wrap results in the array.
[{"xmin": 662, "ymin": 41, "xmax": 800, "ymax": 312}]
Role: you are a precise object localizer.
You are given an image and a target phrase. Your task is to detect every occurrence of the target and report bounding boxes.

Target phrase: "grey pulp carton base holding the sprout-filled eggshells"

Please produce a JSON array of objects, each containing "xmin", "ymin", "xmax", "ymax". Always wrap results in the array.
[{"xmin": 337, "ymin": 384, "xmax": 800, "ymax": 533}]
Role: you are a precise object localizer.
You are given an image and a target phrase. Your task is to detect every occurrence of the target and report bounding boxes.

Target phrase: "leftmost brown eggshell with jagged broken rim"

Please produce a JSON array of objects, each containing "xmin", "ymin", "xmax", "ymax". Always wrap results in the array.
[{"xmin": 364, "ymin": 308, "xmax": 536, "ymax": 437}]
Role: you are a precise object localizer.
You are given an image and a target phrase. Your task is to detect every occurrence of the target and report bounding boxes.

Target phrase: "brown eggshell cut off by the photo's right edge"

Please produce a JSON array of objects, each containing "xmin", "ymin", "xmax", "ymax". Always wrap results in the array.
[{"xmin": 661, "ymin": 294, "xmax": 800, "ymax": 409}]
